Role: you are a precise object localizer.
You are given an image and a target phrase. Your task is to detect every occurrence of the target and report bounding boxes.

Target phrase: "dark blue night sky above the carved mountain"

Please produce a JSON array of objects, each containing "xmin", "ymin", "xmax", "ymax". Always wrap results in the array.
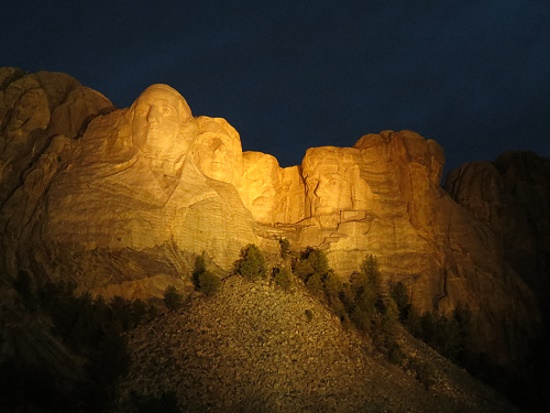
[{"xmin": 4, "ymin": 0, "xmax": 550, "ymax": 174}]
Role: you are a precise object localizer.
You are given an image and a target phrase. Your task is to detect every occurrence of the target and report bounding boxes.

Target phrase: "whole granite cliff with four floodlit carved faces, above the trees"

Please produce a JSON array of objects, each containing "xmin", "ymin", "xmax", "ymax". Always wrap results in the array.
[{"xmin": 0, "ymin": 68, "xmax": 548, "ymax": 362}]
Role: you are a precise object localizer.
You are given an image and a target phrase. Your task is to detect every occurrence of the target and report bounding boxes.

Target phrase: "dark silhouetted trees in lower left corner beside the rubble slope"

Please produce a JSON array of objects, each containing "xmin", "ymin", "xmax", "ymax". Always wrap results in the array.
[{"xmin": 0, "ymin": 273, "xmax": 154, "ymax": 412}]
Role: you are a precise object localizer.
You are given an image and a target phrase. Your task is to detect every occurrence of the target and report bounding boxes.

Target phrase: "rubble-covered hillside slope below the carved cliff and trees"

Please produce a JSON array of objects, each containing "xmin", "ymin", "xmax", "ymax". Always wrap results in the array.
[{"xmin": 115, "ymin": 276, "xmax": 516, "ymax": 412}]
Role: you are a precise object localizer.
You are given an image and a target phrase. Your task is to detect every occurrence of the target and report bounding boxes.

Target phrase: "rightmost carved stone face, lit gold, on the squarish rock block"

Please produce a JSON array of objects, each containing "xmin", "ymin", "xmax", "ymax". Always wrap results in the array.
[{"xmin": 302, "ymin": 147, "xmax": 368, "ymax": 216}]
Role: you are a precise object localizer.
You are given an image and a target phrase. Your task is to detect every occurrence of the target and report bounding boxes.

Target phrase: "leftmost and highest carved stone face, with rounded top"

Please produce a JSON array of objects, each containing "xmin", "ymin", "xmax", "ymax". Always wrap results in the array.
[{"xmin": 131, "ymin": 84, "xmax": 194, "ymax": 159}]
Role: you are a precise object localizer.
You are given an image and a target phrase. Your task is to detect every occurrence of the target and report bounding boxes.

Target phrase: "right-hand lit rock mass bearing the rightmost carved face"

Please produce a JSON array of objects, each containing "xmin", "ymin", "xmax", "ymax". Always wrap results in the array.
[{"xmin": 298, "ymin": 131, "xmax": 540, "ymax": 359}]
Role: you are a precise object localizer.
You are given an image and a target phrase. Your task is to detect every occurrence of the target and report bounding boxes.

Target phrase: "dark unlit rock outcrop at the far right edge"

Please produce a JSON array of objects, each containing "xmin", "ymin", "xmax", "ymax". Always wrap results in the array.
[{"xmin": 445, "ymin": 152, "xmax": 550, "ymax": 320}]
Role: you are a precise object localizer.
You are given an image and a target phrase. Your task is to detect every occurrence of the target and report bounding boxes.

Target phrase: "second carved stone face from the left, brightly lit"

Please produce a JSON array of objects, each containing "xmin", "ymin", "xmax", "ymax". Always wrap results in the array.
[{"xmin": 195, "ymin": 116, "xmax": 243, "ymax": 184}]
